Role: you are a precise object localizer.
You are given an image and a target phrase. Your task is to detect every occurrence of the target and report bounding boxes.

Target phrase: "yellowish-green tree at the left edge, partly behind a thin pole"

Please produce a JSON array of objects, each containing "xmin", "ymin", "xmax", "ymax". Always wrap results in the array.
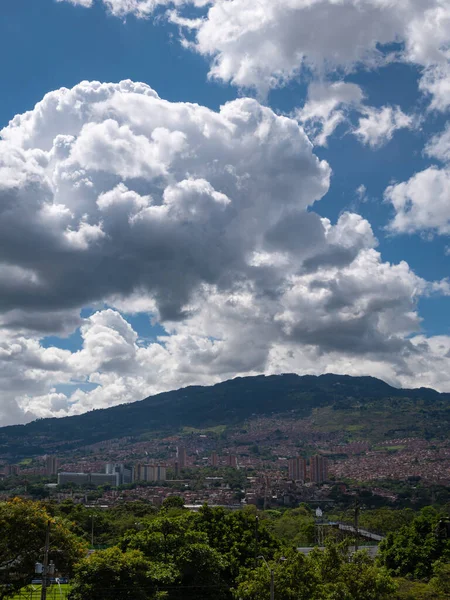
[{"xmin": 0, "ymin": 498, "xmax": 86, "ymax": 598}]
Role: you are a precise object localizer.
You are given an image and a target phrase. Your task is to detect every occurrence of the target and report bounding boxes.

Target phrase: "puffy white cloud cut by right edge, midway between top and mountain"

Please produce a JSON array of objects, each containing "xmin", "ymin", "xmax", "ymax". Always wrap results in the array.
[{"xmin": 385, "ymin": 167, "xmax": 450, "ymax": 235}]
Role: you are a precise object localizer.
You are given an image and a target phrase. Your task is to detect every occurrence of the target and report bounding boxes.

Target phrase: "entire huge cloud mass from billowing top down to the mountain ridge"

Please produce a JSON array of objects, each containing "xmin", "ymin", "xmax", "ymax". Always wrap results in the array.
[{"xmin": 0, "ymin": 81, "xmax": 448, "ymax": 423}]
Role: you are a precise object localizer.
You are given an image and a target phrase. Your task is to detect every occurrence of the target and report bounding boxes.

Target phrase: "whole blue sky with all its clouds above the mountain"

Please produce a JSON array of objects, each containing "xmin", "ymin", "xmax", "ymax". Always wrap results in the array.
[{"xmin": 0, "ymin": 0, "xmax": 450, "ymax": 425}]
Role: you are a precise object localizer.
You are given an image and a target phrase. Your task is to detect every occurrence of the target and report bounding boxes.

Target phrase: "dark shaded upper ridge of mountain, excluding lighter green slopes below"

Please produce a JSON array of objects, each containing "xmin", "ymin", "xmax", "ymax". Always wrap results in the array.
[{"xmin": 0, "ymin": 373, "xmax": 450, "ymax": 454}]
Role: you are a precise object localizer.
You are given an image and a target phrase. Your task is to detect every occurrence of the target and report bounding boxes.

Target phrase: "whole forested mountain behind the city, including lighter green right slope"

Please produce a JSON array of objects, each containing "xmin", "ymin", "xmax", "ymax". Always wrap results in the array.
[{"xmin": 0, "ymin": 374, "xmax": 450, "ymax": 456}]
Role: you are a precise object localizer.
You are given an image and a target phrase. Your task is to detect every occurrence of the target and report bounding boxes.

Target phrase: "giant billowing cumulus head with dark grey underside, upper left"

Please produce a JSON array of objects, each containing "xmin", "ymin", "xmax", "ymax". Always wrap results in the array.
[{"xmin": 0, "ymin": 82, "xmax": 330, "ymax": 318}]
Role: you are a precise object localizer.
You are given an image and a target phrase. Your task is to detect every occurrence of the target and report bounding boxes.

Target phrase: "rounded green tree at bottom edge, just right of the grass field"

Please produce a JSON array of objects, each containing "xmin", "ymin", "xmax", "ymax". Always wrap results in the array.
[{"xmin": 70, "ymin": 546, "xmax": 161, "ymax": 600}]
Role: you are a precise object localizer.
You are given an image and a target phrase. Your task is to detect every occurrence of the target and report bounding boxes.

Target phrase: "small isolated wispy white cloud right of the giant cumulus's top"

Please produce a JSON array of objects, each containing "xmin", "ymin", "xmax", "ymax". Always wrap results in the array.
[{"xmin": 353, "ymin": 106, "xmax": 413, "ymax": 148}]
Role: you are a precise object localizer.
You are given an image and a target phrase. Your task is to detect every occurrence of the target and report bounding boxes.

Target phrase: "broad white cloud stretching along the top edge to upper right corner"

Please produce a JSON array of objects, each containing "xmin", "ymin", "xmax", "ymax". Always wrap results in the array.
[{"xmin": 58, "ymin": 0, "xmax": 450, "ymax": 111}]
